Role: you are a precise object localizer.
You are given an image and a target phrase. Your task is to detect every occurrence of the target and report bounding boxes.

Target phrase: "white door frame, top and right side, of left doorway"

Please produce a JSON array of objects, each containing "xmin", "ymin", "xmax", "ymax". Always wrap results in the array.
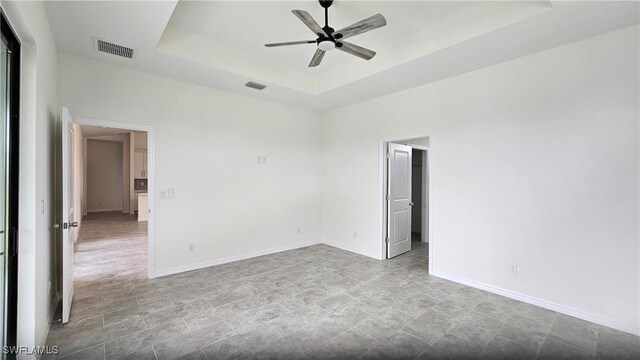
[{"xmin": 73, "ymin": 116, "xmax": 156, "ymax": 279}]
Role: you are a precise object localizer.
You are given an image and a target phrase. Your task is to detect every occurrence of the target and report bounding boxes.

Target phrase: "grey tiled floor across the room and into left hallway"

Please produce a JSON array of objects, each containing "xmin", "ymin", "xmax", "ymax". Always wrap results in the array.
[{"xmin": 48, "ymin": 215, "xmax": 640, "ymax": 359}]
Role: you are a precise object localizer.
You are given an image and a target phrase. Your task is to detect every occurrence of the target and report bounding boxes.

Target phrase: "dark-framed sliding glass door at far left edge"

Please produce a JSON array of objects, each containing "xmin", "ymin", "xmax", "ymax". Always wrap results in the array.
[{"xmin": 0, "ymin": 9, "xmax": 20, "ymax": 351}]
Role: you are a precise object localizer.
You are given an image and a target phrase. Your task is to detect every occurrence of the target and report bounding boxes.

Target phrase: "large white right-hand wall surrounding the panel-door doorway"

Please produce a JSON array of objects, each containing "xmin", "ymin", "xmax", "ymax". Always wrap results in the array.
[{"xmin": 323, "ymin": 26, "xmax": 640, "ymax": 333}]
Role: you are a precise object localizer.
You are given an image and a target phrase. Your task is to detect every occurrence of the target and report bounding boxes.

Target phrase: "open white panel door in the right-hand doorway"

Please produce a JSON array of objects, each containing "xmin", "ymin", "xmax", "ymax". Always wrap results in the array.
[{"xmin": 386, "ymin": 144, "xmax": 413, "ymax": 259}]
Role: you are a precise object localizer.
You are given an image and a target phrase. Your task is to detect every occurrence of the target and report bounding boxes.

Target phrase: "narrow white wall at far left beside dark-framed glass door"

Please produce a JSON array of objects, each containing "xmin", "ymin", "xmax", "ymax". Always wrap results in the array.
[{"xmin": 0, "ymin": 1, "xmax": 60, "ymax": 346}]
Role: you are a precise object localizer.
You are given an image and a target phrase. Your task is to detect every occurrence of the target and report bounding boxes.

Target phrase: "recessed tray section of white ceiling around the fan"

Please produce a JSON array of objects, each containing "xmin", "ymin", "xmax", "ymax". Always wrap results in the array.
[{"xmin": 158, "ymin": 1, "xmax": 551, "ymax": 94}]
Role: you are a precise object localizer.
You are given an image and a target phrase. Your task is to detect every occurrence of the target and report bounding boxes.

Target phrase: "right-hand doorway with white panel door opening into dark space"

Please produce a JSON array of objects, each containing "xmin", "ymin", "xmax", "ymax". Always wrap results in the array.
[{"xmin": 383, "ymin": 137, "xmax": 431, "ymax": 259}]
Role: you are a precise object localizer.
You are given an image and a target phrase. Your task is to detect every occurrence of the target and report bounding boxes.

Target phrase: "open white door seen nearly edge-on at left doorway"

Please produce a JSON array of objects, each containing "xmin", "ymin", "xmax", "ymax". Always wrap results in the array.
[{"xmin": 56, "ymin": 108, "xmax": 78, "ymax": 323}]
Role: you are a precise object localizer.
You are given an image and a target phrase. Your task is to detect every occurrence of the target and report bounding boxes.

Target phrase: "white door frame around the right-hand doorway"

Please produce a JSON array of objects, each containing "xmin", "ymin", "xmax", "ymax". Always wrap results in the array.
[{"xmin": 378, "ymin": 134, "xmax": 435, "ymax": 273}]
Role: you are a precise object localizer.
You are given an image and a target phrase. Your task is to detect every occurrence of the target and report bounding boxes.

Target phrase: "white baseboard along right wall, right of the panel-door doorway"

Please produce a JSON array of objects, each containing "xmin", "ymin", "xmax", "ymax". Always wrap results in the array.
[{"xmin": 431, "ymin": 271, "xmax": 640, "ymax": 335}]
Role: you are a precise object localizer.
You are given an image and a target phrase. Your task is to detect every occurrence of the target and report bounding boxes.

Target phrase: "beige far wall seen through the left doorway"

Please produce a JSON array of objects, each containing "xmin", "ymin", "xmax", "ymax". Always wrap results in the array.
[{"xmin": 87, "ymin": 139, "xmax": 123, "ymax": 212}]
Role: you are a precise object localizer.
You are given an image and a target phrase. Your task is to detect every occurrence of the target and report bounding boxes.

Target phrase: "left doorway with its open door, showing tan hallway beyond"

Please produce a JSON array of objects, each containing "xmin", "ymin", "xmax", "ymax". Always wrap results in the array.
[{"xmin": 59, "ymin": 108, "xmax": 155, "ymax": 323}]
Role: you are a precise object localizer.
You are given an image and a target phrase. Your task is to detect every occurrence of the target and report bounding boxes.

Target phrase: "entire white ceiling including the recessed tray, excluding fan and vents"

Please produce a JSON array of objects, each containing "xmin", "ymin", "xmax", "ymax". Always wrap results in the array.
[{"xmin": 46, "ymin": 0, "xmax": 640, "ymax": 111}]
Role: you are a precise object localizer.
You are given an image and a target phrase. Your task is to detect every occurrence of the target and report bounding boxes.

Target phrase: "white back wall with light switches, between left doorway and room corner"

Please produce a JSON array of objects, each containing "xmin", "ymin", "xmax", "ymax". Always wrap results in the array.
[{"xmin": 59, "ymin": 54, "xmax": 321, "ymax": 273}]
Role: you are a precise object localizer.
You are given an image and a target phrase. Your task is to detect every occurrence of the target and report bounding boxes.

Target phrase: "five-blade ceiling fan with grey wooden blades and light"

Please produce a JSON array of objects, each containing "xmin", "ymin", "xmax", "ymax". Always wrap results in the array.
[{"xmin": 265, "ymin": 0, "xmax": 387, "ymax": 67}]
